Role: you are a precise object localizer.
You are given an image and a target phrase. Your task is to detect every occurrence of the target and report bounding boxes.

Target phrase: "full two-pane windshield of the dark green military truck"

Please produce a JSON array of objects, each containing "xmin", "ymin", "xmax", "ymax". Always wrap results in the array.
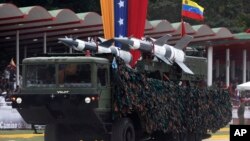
[{"xmin": 25, "ymin": 63, "xmax": 92, "ymax": 87}]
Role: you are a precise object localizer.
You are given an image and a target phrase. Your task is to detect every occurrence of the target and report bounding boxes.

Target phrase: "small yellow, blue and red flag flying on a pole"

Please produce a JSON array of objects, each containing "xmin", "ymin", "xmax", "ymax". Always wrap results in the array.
[{"xmin": 182, "ymin": 0, "xmax": 204, "ymax": 21}]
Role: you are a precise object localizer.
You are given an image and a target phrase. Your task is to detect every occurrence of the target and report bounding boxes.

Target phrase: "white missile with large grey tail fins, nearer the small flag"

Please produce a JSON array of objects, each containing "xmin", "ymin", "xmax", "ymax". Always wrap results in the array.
[{"xmin": 114, "ymin": 34, "xmax": 194, "ymax": 74}]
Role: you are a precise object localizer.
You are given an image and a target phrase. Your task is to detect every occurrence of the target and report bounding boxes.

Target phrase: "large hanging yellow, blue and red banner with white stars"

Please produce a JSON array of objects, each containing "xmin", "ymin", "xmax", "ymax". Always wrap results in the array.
[{"xmin": 100, "ymin": 0, "xmax": 148, "ymax": 66}]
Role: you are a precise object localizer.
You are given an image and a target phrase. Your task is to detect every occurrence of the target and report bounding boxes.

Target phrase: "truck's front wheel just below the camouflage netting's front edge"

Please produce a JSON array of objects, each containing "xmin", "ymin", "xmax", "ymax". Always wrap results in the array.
[{"xmin": 111, "ymin": 118, "xmax": 135, "ymax": 141}]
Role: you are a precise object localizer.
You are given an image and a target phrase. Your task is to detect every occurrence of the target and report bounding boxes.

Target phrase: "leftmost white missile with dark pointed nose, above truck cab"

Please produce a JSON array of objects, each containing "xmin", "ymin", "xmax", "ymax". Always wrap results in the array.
[{"xmin": 58, "ymin": 37, "xmax": 132, "ymax": 64}]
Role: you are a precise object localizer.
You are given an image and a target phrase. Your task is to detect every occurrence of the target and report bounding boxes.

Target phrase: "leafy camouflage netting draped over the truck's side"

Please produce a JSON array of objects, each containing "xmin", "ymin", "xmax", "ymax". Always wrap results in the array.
[{"xmin": 114, "ymin": 58, "xmax": 232, "ymax": 133}]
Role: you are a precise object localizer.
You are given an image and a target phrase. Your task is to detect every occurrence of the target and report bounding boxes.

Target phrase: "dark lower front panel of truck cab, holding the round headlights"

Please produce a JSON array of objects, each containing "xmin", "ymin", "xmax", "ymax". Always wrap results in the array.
[{"xmin": 11, "ymin": 94, "xmax": 100, "ymax": 124}]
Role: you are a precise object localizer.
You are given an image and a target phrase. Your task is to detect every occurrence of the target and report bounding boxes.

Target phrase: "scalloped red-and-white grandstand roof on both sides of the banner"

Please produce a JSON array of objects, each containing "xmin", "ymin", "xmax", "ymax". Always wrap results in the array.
[{"xmin": 0, "ymin": 3, "xmax": 250, "ymax": 54}]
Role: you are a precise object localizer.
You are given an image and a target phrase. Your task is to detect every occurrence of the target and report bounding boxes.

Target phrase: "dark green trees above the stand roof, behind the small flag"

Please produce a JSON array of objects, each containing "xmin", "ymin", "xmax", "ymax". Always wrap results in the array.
[{"xmin": 148, "ymin": 0, "xmax": 250, "ymax": 32}]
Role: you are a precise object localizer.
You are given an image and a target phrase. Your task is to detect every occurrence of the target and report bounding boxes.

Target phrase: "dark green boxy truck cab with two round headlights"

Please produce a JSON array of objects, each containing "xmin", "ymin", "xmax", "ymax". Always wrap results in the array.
[{"xmin": 11, "ymin": 56, "xmax": 111, "ymax": 141}]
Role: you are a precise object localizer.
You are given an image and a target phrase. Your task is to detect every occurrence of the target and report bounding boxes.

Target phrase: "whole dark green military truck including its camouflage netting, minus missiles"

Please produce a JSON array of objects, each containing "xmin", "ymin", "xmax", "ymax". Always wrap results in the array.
[{"xmin": 10, "ymin": 35, "xmax": 232, "ymax": 141}]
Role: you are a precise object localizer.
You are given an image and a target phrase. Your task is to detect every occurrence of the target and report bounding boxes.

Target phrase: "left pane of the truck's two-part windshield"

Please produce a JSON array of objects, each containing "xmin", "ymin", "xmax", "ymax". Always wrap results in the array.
[{"xmin": 25, "ymin": 64, "xmax": 56, "ymax": 87}]
